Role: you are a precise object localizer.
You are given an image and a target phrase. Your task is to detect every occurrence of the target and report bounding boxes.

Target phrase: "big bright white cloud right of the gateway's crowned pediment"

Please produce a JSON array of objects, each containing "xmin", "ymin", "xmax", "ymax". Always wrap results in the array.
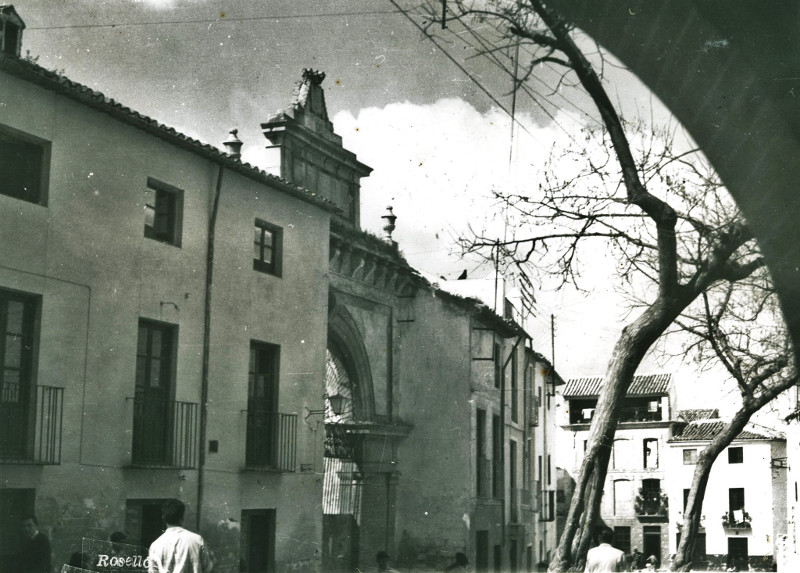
[{"xmin": 333, "ymin": 98, "xmax": 580, "ymax": 280}]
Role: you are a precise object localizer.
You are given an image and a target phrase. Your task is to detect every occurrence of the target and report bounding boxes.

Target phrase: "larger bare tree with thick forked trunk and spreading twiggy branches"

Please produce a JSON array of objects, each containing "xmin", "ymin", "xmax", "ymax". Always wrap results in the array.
[{"xmin": 392, "ymin": 0, "xmax": 780, "ymax": 571}]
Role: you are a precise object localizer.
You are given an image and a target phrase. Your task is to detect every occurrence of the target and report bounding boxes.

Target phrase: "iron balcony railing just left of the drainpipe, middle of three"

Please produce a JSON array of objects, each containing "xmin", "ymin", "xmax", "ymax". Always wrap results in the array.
[{"xmin": 131, "ymin": 389, "xmax": 198, "ymax": 468}]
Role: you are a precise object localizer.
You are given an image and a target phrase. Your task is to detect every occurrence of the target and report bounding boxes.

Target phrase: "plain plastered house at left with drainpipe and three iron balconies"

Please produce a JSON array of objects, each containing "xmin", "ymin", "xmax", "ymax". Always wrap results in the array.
[{"xmin": 0, "ymin": 13, "xmax": 338, "ymax": 572}]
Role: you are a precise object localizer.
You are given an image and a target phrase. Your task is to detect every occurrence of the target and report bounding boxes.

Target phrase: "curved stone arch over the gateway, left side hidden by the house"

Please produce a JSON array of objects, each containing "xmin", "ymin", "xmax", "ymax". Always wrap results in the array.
[{"xmin": 326, "ymin": 296, "xmax": 375, "ymax": 421}]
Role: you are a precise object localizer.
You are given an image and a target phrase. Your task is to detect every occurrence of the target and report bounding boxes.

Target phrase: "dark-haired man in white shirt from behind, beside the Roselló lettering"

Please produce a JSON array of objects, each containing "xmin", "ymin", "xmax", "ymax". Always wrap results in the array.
[{"xmin": 148, "ymin": 499, "xmax": 213, "ymax": 573}]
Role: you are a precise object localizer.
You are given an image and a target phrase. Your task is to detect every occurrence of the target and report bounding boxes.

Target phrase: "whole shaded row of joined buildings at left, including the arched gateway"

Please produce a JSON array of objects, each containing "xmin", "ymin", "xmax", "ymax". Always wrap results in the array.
[{"xmin": 0, "ymin": 8, "xmax": 558, "ymax": 573}]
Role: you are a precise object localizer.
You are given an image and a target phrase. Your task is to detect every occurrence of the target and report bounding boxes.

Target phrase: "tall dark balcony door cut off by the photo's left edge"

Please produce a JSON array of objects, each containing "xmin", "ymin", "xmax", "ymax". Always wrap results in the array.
[{"xmin": 0, "ymin": 290, "xmax": 38, "ymax": 460}]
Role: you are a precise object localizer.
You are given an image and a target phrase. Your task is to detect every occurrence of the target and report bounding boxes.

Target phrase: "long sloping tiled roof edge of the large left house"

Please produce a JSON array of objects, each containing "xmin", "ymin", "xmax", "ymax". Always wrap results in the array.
[{"xmin": 0, "ymin": 53, "xmax": 339, "ymax": 212}]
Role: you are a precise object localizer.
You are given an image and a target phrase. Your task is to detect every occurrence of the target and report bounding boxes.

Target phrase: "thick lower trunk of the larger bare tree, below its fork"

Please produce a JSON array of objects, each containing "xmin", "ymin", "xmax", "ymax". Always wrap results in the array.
[{"xmin": 548, "ymin": 297, "xmax": 688, "ymax": 573}]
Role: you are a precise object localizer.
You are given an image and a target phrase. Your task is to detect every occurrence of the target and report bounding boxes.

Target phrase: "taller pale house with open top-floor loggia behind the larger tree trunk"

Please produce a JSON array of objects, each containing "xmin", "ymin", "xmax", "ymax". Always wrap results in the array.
[{"xmin": 559, "ymin": 374, "xmax": 675, "ymax": 563}]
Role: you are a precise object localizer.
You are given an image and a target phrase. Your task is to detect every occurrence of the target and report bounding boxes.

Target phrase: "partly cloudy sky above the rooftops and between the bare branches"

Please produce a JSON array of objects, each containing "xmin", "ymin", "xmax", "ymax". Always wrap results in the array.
[{"xmin": 7, "ymin": 0, "xmax": 776, "ymax": 418}]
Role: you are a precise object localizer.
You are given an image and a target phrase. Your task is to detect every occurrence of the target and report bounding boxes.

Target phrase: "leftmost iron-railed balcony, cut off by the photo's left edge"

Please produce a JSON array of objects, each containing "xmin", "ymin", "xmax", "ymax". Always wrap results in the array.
[{"xmin": 0, "ymin": 382, "xmax": 64, "ymax": 465}]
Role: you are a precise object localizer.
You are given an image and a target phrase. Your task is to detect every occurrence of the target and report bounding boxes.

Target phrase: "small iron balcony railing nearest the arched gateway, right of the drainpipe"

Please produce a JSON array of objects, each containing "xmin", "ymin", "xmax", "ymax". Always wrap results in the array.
[{"xmin": 245, "ymin": 410, "xmax": 297, "ymax": 472}]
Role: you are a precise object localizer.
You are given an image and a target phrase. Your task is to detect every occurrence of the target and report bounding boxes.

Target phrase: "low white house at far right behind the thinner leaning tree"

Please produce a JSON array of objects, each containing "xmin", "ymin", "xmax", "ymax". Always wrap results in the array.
[{"xmin": 667, "ymin": 410, "xmax": 788, "ymax": 571}]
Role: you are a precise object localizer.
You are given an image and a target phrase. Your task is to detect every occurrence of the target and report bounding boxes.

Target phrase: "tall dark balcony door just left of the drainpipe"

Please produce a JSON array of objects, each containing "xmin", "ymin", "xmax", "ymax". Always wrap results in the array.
[{"xmin": 132, "ymin": 320, "xmax": 177, "ymax": 465}]
